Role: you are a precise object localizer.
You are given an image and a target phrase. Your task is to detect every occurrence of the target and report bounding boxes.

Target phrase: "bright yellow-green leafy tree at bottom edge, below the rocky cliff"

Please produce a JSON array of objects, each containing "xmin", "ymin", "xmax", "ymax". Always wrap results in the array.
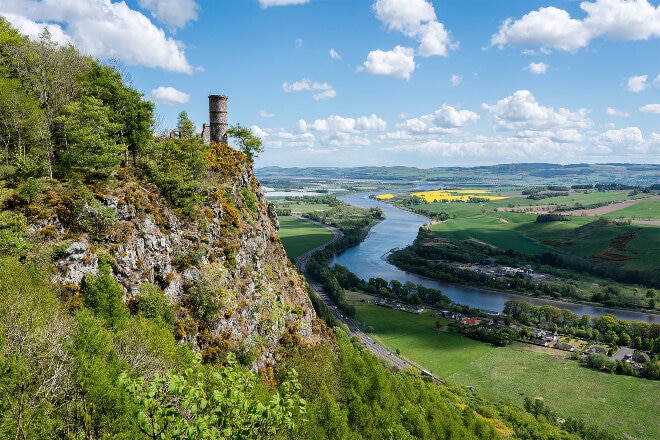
[{"xmin": 119, "ymin": 355, "xmax": 306, "ymax": 439}]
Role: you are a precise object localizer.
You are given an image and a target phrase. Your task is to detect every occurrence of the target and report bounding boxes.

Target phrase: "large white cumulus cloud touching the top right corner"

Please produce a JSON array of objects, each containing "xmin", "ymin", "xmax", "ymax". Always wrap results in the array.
[{"xmin": 491, "ymin": 0, "xmax": 660, "ymax": 52}]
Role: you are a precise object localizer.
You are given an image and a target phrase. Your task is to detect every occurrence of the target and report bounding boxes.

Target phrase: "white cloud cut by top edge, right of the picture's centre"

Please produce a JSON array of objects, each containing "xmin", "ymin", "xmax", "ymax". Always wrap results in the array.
[{"xmin": 373, "ymin": 0, "xmax": 457, "ymax": 57}]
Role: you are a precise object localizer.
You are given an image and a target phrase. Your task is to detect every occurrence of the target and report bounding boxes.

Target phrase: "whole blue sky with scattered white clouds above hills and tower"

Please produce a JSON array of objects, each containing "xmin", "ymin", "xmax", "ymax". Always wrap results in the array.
[{"xmin": 0, "ymin": 0, "xmax": 660, "ymax": 168}]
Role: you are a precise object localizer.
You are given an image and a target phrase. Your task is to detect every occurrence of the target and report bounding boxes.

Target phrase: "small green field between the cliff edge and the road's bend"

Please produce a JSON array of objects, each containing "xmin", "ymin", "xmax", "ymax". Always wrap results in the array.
[{"xmin": 278, "ymin": 216, "xmax": 332, "ymax": 260}]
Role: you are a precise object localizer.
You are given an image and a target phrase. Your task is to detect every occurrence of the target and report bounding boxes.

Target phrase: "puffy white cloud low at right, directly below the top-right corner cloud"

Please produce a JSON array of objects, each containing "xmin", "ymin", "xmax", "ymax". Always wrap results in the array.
[{"xmin": 482, "ymin": 90, "xmax": 593, "ymax": 132}]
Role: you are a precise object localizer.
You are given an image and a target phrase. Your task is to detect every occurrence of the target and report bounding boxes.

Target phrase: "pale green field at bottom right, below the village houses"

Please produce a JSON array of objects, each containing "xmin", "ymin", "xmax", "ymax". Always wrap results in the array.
[{"xmin": 447, "ymin": 343, "xmax": 660, "ymax": 440}]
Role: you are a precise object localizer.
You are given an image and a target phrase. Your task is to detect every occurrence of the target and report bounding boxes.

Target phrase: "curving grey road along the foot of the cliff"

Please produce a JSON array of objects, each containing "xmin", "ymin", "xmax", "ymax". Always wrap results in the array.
[{"xmin": 296, "ymin": 217, "xmax": 441, "ymax": 383}]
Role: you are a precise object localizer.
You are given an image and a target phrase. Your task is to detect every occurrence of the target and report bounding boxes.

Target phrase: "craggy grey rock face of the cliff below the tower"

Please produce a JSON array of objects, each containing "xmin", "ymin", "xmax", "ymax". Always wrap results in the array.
[{"xmin": 55, "ymin": 156, "xmax": 319, "ymax": 368}]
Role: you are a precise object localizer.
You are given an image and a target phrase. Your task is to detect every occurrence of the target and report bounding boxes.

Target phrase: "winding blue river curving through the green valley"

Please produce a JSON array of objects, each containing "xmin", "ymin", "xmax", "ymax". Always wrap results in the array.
[{"xmin": 333, "ymin": 193, "xmax": 660, "ymax": 323}]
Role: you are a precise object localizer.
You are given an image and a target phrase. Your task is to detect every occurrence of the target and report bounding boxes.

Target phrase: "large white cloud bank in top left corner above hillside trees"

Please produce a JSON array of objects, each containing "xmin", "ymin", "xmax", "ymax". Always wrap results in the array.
[{"xmin": 0, "ymin": 0, "xmax": 193, "ymax": 73}]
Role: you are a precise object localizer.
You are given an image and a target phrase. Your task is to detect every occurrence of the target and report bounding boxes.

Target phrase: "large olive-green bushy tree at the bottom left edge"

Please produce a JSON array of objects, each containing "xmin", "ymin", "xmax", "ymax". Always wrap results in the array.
[{"xmin": 0, "ymin": 258, "xmax": 72, "ymax": 439}]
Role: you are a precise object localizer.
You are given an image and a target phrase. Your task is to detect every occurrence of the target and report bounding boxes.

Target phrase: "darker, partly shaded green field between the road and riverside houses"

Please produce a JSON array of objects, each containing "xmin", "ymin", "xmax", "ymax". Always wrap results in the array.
[{"xmin": 353, "ymin": 302, "xmax": 493, "ymax": 377}]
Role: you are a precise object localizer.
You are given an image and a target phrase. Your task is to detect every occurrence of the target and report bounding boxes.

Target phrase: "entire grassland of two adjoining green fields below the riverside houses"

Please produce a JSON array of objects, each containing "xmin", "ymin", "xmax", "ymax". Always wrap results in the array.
[{"xmin": 352, "ymin": 302, "xmax": 660, "ymax": 440}]
